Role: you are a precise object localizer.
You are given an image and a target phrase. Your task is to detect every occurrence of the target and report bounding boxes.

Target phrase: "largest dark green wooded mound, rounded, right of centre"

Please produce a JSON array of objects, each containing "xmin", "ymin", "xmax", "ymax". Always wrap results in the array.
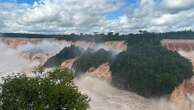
[{"xmin": 111, "ymin": 41, "xmax": 193, "ymax": 97}]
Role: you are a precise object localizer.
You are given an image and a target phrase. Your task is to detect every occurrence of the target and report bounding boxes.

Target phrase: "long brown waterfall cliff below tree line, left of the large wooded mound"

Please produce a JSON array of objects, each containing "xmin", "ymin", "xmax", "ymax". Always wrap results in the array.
[{"xmin": 0, "ymin": 38, "xmax": 127, "ymax": 64}]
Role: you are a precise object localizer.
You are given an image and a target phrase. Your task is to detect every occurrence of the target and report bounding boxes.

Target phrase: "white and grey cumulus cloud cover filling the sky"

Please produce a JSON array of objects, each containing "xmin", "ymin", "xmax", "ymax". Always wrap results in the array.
[{"xmin": 0, "ymin": 0, "xmax": 194, "ymax": 34}]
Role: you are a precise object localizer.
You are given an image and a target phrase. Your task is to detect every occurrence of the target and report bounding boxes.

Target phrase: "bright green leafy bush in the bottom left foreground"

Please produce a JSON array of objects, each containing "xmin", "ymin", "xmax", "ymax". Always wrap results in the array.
[{"xmin": 0, "ymin": 69, "xmax": 89, "ymax": 110}]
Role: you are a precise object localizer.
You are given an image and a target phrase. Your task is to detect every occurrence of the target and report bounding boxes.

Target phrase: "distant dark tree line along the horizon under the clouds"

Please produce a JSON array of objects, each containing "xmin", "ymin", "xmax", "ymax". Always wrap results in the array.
[{"xmin": 0, "ymin": 30, "xmax": 194, "ymax": 42}]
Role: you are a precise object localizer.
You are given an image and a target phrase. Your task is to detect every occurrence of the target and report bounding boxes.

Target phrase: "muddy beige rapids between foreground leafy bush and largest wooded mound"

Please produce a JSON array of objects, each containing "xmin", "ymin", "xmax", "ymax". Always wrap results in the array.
[{"xmin": 75, "ymin": 75, "xmax": 148, "ymax": 110}]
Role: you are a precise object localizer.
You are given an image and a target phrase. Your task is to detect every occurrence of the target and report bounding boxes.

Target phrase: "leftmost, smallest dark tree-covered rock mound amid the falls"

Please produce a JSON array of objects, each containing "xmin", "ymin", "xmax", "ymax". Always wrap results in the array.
[{"xmin": 44, "ymin": 46, "xmax": 82, "ymax": 68}]
